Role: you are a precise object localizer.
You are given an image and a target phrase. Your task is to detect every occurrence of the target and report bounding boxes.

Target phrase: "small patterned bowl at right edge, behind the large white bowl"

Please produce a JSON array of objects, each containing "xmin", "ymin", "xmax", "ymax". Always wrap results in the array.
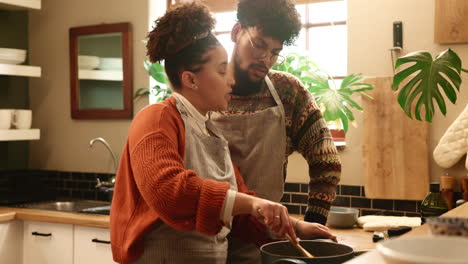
[{"xmin": 426, "ymin": 217, "xmax": 468, "ymax": 238}]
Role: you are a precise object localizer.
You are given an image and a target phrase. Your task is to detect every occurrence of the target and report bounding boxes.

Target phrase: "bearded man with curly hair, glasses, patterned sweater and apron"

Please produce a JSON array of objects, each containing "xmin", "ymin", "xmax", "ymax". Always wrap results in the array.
[{"xmin": 212, "ymin": 0, "xmax": 341, "ymax": 263}]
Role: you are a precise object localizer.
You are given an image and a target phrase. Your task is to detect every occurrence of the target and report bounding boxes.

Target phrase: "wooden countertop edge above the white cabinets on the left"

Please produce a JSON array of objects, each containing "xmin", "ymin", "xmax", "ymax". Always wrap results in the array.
[{"xmin": 0, "ymin": 207, "xmax": 109, "ymax": 228}]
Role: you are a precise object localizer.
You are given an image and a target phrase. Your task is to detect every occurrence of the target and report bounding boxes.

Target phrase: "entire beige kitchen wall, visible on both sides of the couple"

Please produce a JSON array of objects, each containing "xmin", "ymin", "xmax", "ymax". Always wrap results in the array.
[{"xmin": 29, "ymin": 0, "xmax": 468, "ymax": 192}]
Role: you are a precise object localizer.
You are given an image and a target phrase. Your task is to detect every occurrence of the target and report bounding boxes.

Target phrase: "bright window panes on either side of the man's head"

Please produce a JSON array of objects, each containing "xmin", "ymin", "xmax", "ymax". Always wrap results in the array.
[{"xmin": 215, "ymin": 0, "xmax": 348, "ymax": 79}]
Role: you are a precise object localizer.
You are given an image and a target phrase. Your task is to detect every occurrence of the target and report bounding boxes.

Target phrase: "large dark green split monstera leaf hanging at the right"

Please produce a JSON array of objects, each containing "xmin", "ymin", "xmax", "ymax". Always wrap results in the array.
[{"xmin": 393, "ymin": 49, "xmax": 466, "ymax": 122}]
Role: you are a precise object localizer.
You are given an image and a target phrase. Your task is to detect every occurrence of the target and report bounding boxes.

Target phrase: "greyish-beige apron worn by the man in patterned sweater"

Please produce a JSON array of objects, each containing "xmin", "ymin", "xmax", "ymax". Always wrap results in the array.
[{"xmin": 211, "ymin": 76, "xmax": 286, "ymax": 264}]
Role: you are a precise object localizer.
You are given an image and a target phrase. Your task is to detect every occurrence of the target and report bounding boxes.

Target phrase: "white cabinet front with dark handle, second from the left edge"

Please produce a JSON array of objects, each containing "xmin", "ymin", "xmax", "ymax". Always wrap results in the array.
[{"xmin": 23, "ymin": 221, "xmax": 73, "ymax": 264}]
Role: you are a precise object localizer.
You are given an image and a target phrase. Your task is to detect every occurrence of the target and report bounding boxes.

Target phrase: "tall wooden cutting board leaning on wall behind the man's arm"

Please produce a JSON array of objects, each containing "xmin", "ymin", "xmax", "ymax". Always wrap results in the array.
[{"xmin": 362, "ymin": 77, "xmax": 430, "ymax": 200}]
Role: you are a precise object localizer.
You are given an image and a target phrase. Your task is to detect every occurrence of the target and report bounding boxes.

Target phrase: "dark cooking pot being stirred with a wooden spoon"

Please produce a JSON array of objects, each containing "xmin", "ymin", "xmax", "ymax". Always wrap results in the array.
[{"xmin": 260, "ymin": 240, "xmax": 354, "ymax": 264}]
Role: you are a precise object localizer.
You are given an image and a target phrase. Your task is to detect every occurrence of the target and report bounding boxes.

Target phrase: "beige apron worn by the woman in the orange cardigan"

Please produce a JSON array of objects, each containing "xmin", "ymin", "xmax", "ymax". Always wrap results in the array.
[{"xmin": 135, "ymin": 99, "xmax": 237, "ymax": 264}]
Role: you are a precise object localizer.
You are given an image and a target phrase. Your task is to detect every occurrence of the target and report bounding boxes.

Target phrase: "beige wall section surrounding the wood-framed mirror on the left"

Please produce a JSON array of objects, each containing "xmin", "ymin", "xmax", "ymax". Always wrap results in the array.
[{"xmin": 29, "ymin": 0, "xmax": 149, "ymax": 172}]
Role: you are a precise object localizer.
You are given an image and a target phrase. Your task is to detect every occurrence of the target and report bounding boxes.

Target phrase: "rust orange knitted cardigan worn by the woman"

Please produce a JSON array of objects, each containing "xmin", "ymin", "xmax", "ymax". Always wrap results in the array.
[{"xmin": 110, "ymin": 97, "xmax": 269, "ymax": 263}]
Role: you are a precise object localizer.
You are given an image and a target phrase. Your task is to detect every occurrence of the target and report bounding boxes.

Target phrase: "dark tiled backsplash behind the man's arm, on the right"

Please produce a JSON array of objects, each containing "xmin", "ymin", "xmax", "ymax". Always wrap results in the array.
[{"xmin": 281, "ymin": 183, "xmax": 461, "ymax": 216}]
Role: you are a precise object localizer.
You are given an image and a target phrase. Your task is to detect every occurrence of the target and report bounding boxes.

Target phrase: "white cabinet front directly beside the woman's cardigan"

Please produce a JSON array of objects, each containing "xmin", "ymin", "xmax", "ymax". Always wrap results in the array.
[{"xmin": 73, "ymin": 226, "xmax": 115, "ymax": 264}]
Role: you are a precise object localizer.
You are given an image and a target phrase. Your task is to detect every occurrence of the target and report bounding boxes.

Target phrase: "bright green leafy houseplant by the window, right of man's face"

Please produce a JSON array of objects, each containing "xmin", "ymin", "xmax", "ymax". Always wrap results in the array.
[{"xmin": 273, "ymin": 53, "xmax": 374, "ymax": 132}]
